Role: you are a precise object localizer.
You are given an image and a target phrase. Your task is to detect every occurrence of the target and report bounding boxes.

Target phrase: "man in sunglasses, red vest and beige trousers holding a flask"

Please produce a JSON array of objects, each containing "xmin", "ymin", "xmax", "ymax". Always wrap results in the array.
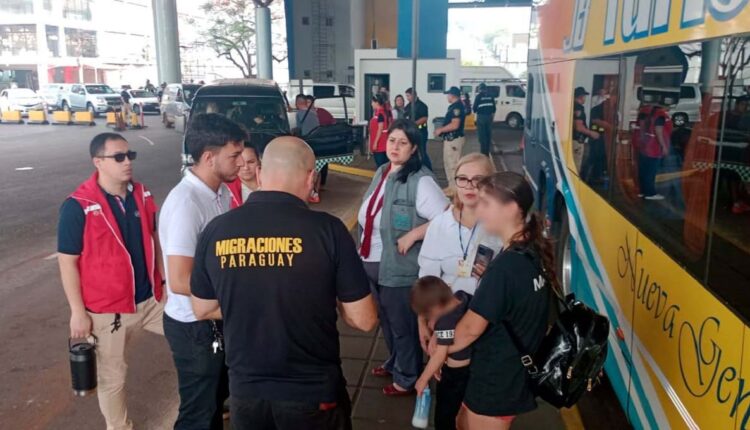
[{"xmin": 58, "ymin": 133, "xmax": 164, "ymax": 430}]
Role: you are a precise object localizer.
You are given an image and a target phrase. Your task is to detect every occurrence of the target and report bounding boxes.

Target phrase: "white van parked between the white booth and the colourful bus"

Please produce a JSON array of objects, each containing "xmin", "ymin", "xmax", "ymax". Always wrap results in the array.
[{"xmin": 461, "ymin": 78, "xmax": 526, "ymax": 128}]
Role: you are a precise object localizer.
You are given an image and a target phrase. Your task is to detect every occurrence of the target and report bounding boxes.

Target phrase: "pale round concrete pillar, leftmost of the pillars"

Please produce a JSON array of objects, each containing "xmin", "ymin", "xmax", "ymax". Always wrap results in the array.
[{"xmin": 151, "ymin": 0, "xmax": 182, "ymax": 83}]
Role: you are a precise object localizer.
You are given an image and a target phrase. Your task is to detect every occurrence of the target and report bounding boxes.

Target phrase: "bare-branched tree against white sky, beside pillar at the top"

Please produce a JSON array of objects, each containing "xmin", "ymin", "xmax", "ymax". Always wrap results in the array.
[{"xmin": 201, "ymin": 0, "xmax": 287, "ymax": 78}]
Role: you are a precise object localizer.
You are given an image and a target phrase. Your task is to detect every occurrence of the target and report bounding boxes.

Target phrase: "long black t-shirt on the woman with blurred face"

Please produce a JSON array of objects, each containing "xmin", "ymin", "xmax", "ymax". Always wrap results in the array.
[{"xmin": 464, "ymin": 248, "xmax": 550, "ymax": 416}]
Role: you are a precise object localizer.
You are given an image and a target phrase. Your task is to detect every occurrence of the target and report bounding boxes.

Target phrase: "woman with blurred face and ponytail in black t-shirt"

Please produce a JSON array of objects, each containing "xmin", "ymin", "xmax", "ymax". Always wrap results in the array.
[{"xmin": 448, "ymin": 172, "xmax": 559, "ymax": 430}]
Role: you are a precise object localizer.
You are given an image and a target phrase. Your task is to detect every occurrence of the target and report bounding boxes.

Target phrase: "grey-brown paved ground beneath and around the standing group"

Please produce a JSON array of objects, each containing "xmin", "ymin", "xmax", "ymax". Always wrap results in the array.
[{"xmin": 0, "ymin": 116, "xmax": 621, "ymax": 430}]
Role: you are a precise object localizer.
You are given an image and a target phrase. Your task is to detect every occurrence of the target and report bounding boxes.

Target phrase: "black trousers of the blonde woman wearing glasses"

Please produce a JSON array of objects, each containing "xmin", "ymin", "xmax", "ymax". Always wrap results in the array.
[{"xmin": 435, "ymin": 366, "xmax": 469, "ymax": 430}]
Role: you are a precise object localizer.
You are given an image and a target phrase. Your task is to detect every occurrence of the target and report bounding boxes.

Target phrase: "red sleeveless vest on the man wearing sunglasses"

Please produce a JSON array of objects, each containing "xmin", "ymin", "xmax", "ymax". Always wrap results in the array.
[{"xmin": 70, "ymin": 172, "xmax": 162, "ymax": 314}]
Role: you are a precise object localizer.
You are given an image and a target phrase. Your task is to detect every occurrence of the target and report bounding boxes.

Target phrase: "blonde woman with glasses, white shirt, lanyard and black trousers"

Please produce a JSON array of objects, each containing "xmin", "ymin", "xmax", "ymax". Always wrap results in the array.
[{"xmin": 418, "ymin": 152, "xmax": 502, "ymax": 430}]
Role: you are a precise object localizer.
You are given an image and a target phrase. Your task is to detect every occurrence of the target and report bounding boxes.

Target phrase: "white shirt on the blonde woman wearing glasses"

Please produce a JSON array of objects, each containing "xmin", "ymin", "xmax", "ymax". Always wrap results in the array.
[{"xmin": 418, "ymin": 207, "xmax": 502, "ymax": 295}]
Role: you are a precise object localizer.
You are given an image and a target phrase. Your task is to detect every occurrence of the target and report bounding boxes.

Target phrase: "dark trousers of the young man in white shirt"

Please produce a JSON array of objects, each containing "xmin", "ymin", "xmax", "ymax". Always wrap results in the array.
[{"xmin": 164, "ymin": 314, "xmax": 229, "ymax": 430}]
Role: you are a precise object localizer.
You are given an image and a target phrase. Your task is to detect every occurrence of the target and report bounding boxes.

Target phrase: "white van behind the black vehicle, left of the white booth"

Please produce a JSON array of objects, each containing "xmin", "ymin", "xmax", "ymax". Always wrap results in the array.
[{"xmin": 280, "ymin": 79, "xmax": 357, "ymax": 124}]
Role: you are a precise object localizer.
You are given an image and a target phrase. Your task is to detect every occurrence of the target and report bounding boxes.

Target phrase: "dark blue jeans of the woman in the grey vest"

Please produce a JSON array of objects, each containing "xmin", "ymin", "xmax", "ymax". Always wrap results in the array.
[{"xmin": 364, "ymin": 263, "xmax": 422, "ymax": 390}]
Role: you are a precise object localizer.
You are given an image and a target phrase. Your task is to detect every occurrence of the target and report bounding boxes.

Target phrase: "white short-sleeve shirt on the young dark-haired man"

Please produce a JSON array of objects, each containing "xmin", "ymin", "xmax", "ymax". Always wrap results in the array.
[{"xmin": 159, "ymin": 170, "xmax": 232, "ymax": 323}]
